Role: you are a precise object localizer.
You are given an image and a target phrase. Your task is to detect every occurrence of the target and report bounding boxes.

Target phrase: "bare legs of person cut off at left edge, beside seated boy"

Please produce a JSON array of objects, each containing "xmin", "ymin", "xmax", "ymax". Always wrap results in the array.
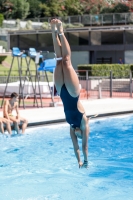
[{"xmin": 0, "ymin": 117, "xmax": 12, "ymax": 134}]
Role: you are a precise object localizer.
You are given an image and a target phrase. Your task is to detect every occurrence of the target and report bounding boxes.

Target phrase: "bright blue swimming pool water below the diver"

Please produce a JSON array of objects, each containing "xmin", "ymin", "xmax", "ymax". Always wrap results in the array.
[{"xmin": 0, "ymin": 116, "xmax": 133, "ymax": 200}]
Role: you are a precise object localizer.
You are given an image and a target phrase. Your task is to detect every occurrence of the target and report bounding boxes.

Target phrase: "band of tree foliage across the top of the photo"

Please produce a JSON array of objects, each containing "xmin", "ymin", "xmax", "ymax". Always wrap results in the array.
[{"xmin": 0, "ymin": 0, "xmax": 133, "ymax": 19}]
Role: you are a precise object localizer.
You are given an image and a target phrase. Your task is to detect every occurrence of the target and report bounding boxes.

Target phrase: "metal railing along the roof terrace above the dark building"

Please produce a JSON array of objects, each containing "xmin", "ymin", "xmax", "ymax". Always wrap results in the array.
[{"xmin": 3, "ymin": 13, "xmax": 133, "ymax": 30}]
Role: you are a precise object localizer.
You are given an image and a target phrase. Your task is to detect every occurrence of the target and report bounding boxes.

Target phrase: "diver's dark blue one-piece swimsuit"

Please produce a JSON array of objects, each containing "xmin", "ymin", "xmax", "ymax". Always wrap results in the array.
[{"xmin": 60, "ymin": 84, "xmax": 84, "ymax": 128}]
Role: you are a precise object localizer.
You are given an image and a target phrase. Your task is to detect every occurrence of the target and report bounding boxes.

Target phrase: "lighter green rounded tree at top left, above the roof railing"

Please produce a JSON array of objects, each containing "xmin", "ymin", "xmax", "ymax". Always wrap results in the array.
[{"xmin": 10, "ymin": 0, "xmax": 29, "ymax": 19}]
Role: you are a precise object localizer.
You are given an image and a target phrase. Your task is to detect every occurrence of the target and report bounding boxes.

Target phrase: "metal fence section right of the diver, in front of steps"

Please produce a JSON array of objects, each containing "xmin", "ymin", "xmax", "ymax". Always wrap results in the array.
[{"xmin": 78, "ymin": 70, "xmax": 133, "ymax": 99}]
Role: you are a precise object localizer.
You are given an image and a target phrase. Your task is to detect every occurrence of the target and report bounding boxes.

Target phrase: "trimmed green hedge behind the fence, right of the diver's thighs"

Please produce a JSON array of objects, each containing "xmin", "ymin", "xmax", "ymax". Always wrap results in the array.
[{"xmin": 78, "ymin": 64, "xmax": 133, "ymax": 78}]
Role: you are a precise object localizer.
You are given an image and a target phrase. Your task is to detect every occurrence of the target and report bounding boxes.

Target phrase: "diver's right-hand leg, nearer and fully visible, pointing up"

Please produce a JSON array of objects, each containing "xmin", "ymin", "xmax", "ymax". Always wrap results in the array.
[{"xmin": 56, "ymin": 20, "xmax": 80, "ymax": 97}]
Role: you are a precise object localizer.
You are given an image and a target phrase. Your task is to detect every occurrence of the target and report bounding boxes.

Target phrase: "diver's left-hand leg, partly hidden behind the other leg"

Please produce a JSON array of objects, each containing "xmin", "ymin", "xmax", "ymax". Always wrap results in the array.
[{"xmin": 51, "ymin": 19, "xmax": 64, "ymax": 94}]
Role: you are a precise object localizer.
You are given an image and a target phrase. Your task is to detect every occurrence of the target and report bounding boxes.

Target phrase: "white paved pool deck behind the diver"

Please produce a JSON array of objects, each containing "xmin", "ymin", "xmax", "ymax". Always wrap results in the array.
[{"xmin": 0, "ymin": 98, "xmax": 133, "ymax": 123}]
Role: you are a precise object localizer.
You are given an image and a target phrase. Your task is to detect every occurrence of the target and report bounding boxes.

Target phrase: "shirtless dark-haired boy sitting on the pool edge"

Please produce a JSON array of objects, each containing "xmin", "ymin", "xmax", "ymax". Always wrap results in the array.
[{"xmin": 3, "ymin": 92, "xmax": 28, "ymax": 133}]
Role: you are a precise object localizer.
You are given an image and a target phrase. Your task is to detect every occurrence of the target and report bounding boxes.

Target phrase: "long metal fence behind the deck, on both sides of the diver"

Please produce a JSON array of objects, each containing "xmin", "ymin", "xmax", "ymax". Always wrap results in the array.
[{"xmin": 0, "ymin": 70, "xmax": 133, "ymax": 99}]
